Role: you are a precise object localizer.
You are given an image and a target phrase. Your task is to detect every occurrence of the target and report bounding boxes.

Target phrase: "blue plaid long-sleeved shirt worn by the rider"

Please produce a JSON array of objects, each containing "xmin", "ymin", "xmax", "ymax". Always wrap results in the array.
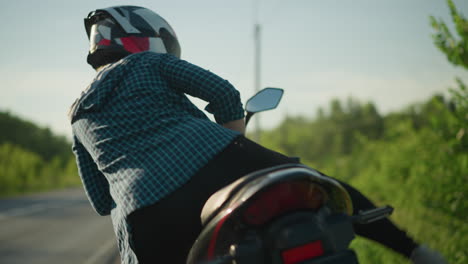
[{"xmin": 70, "ymin": 52, "xmax": 244, "ymax": 263}]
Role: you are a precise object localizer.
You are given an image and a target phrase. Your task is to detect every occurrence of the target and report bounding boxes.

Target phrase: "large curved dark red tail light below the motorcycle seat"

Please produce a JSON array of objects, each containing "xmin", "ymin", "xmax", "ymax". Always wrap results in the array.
[{"xmin": 243, "ymin": 180, "xmax": 326, "ymax": 226}]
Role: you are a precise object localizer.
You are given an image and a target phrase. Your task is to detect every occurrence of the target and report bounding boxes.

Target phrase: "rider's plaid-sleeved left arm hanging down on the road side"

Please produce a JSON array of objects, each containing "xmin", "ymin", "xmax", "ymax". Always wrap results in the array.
[{"xmin": 73, "ymin": 136, "xmax": 114, "ymax": 215}]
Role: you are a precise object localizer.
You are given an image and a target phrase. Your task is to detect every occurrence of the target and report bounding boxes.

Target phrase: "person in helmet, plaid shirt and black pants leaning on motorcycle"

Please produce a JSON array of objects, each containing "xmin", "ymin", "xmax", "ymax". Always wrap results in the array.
[{"xmin": 69, "ymin": 6, "xmax": 444, "ymax": 264}]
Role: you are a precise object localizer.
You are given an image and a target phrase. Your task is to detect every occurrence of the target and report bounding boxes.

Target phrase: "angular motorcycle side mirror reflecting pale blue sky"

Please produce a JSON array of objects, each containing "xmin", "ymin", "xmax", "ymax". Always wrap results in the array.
[{"xmin": 245, "ymin": 87, "xmax": 284, "ymax": 124}]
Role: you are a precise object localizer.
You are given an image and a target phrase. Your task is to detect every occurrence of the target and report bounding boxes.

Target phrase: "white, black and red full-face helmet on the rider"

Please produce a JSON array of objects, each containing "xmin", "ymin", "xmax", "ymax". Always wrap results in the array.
[{"xmin": 84, "ymin": 6, "xmax": 180, "ymax": 68}]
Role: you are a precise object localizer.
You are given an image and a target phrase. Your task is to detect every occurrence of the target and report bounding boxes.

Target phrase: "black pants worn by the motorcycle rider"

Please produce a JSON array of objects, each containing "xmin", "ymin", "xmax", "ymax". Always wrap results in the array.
[{"xmin": 129, "ymin": 137, "xmax": 417, "ymax": 264}]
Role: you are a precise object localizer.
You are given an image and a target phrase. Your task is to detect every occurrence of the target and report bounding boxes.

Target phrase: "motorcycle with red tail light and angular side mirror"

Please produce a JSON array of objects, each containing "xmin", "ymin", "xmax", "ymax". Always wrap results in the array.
[{"xmin": 187, "ymin": 88, "xmax": 393, "ymax": 264}]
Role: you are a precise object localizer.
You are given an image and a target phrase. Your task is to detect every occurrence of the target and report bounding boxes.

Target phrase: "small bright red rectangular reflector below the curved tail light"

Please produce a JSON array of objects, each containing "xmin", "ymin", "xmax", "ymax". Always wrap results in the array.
[{"xmin": 281, "ymin": 240, "xmax": 324, "ymax": 264}]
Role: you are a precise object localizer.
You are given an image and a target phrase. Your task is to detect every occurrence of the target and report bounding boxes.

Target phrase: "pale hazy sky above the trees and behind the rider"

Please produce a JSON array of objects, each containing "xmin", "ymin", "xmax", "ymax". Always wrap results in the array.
[{"xmin": 0, "ymin": 0, "xmax": 468, "ymax": 137}]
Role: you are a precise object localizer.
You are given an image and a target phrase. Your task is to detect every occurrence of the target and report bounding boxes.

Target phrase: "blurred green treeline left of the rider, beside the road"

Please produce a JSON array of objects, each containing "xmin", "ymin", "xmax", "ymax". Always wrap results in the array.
[{"xmin": 0, "ymin": 112, "xmax": 80, "ymax": 197}]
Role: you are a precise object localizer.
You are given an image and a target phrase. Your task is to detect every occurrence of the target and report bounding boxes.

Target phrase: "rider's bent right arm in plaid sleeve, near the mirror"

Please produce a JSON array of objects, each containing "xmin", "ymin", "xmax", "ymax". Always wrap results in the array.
[{"xmin": 159, "ymin": 55, "xmax": 244, "ymax": 129}]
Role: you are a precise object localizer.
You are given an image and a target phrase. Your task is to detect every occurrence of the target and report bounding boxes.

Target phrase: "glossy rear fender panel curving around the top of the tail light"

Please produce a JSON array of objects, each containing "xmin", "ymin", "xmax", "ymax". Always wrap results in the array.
[{"xmin": 187, "ymin": 164, "xmax": 353, "ymax": 263}]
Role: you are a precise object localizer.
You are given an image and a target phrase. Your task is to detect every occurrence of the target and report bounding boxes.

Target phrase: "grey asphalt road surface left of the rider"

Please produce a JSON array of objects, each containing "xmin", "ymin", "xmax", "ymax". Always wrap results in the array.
[{"xmin": 0, "ymin": 189, "xmax": 119, "ymax": 264}]
